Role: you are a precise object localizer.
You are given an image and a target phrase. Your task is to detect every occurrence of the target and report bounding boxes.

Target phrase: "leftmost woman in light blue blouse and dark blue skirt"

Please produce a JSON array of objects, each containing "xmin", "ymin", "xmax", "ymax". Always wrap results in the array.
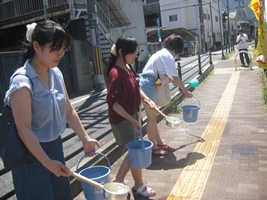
[{"xmin": 4, "ymin": 20, "xmax": 100, "ymax": 200}]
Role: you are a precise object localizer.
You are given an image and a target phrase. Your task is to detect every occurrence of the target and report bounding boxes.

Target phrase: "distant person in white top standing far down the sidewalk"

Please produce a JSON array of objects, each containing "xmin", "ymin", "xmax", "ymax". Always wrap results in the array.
[{"xmin": 236, "ymin": 28, "xmax": 250, "ymax": 67}]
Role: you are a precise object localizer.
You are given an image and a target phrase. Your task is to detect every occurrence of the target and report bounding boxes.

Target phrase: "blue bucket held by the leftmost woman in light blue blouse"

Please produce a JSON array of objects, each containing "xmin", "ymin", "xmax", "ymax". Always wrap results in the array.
[{"xmin": 76, "ymin": 152, "xmax": 110, "ymax": 200}]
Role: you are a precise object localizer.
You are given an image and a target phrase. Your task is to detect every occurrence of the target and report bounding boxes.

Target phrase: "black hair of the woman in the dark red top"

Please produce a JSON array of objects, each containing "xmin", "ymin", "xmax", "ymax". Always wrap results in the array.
[{"xmin": 107, "ymin": 36, "xmax": 138, "ymax": 77}]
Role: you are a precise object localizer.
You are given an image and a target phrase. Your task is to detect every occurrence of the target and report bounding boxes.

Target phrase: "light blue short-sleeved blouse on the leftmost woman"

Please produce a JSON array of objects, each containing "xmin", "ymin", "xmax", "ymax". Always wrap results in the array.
[{"xmin": 4, "ymin": 60, "xmax": 66, "ymax": 142}]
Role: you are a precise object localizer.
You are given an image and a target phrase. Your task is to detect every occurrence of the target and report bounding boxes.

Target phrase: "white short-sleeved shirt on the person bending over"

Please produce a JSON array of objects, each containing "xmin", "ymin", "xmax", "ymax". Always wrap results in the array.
[{"xmin": 142, "ymin": 48, "xmax": 178, "ymax": 77}]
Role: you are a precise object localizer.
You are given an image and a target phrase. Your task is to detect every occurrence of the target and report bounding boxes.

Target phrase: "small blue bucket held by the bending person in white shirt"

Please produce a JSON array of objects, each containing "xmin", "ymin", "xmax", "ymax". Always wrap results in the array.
[{"xmin": 182, "ymin": 96, "xmax": 200, "ymax": 123}]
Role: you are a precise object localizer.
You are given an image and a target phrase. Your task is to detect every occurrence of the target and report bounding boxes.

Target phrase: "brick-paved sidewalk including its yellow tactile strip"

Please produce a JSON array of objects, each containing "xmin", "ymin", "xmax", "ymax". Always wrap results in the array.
[{"xmin": 75, "ymin": 52, "xmax": 267, "ymax": 200}]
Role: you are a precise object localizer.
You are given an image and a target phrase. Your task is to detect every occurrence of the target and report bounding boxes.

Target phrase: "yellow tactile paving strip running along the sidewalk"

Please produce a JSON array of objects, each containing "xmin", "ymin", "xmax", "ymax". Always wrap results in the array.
[{"xmin": 167, "ymin": 72, "xmax": 240, "ymax": 200}]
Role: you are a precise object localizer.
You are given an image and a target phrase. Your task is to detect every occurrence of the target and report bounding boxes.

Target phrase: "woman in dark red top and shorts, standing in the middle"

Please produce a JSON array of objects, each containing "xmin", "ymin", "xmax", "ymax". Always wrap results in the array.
[{"xmin": 107, "ymin": 37, "xmax": 156, "ymax": 197}]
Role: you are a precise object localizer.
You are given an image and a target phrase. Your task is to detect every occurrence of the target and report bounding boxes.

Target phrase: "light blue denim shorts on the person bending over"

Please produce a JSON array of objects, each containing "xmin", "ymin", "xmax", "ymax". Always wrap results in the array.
[{"xmin": 139, "ymin": 74, "xmax": 158, "ymax": 104}]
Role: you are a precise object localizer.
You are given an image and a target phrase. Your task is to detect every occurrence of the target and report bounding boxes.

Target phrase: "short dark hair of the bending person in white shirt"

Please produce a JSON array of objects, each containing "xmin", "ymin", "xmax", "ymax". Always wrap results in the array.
[{"xmin": 164, "ymin": 34, "xmax": 184, "ymax": 54}]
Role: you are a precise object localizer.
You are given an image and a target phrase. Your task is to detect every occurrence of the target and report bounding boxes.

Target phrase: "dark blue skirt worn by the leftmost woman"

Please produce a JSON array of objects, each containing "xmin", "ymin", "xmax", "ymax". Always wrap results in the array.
[{"xmin": 12, "ymin": 137, "xmax": 73, "ymax": 200}]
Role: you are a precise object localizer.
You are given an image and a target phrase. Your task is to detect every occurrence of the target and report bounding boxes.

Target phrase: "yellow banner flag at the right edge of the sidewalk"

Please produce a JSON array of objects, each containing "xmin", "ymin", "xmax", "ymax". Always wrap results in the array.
[{"xmin": 248, "ymin": 0, "xmax": 267, "ymax": 69}]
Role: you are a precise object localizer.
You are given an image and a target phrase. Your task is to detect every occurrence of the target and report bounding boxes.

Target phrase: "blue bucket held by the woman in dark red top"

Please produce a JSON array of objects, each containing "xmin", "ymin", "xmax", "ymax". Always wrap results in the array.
[{"xmin": 126, "ymin": 130, "xmax": 153, "ymax": 169}]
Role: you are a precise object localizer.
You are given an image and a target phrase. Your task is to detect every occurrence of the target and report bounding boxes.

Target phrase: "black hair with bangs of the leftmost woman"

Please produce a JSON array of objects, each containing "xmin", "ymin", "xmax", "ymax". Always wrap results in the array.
[{"xmin": 20, "ymin": 20, "xmax": 70, "ymax": 66}]
